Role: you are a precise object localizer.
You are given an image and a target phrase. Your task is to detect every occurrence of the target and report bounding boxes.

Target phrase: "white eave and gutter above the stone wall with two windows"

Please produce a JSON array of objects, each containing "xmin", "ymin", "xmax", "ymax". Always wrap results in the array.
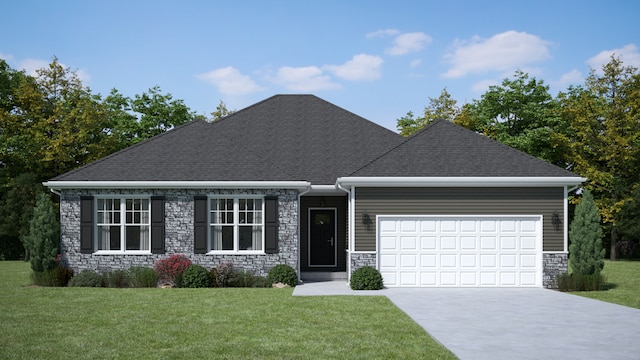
[{"xmin": 42, "ymin": 181, "xmax": 311, "ymax": 190}]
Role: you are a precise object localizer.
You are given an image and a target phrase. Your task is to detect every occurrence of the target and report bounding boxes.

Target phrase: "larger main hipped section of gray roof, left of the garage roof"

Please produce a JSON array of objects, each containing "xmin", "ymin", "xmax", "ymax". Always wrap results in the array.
[{"xmin": 52, "ymin": 95, "xmax": 404, "ymax": 185}]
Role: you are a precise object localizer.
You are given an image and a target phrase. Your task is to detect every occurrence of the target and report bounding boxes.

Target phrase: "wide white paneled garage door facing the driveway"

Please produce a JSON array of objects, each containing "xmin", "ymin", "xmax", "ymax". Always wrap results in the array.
[{"xmin": 377, "ymin": 215, "xmax": 542, "ymax": 287}]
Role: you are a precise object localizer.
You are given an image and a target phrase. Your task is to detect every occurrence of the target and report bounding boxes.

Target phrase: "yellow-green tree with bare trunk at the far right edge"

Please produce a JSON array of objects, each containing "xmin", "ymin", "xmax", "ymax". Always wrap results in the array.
[{"xmin": 559, "ymin": 56, "xmax": 640, "ymax": 260}]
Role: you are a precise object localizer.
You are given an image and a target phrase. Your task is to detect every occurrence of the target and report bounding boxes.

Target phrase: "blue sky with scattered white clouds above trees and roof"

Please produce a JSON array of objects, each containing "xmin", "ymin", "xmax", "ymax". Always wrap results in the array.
[{"xmin": 0, "ymin": 0, "xmax": 640, "ymax": 130}]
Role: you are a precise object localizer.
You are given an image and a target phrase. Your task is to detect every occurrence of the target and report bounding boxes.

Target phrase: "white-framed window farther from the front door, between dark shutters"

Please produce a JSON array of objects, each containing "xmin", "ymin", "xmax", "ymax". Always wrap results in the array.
[{"xmin": 96, "ymin": 198, "xmax": 151, "ymax": 253}]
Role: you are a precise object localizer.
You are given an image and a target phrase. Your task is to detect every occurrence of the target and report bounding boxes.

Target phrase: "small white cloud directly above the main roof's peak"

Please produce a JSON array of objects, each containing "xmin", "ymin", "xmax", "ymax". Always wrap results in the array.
[{"xmin": 274, "ymin": 66, "xmax": 340, "ymax": 92}]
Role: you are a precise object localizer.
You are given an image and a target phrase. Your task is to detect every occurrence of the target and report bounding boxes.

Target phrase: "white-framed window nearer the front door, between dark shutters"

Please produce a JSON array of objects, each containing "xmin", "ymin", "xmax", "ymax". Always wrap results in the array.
[{"xmin": 209, "ymin": 198, "xmax": 264, "ymax": 252}]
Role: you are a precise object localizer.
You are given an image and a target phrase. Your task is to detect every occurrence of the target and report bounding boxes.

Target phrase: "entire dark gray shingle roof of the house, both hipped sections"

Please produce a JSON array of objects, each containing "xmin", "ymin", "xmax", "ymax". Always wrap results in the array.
[{"xmin": 52, "ymin": 95, "xmax": 576, "ymax": 185}]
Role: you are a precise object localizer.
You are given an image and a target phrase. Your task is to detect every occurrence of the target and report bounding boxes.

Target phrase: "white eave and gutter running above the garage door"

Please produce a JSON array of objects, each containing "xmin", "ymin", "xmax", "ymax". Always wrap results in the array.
[{"xmin": 336, "ymin": 176, "xmax": 587, "ymax": 187}]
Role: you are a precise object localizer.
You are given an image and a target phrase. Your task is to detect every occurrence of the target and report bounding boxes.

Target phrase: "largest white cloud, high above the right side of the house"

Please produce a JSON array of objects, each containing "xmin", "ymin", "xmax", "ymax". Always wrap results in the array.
[{"xmin": 443, "ymin": 31, "xmax": 550, "ymax": 78}]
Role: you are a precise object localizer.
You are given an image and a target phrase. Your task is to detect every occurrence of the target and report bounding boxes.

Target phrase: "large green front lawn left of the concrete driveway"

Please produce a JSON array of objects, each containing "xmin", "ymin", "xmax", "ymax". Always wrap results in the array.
[{"xmin": 0, "ymin": 262, "xmax": 455, "ymax": 359}]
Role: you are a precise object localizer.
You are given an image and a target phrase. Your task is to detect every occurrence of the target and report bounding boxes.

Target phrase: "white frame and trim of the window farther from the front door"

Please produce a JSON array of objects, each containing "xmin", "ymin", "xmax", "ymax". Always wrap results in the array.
[{"xmin": 93, "ymin": 194, "xmax": 152, "ymax": 255}]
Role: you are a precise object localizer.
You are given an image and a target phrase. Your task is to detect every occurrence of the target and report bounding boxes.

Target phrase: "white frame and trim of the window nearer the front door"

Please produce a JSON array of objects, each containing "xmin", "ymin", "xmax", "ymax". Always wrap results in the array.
[{"xmin": 207, "ymin": 194, "xmax": 266, "ymax": 255}]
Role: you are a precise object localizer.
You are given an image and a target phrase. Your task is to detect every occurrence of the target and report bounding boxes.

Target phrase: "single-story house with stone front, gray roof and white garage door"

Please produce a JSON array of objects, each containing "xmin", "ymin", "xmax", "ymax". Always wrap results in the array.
[{"xmin": 45, "ymin": 95, "xmax": 585, "ymax": 287}]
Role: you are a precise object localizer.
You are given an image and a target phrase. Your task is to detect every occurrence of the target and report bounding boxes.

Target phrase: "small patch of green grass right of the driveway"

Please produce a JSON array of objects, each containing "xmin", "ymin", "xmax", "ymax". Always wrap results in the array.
[{"xmin": 573, "ymin": 260, "xmax": 640, "ymax": 309}]
